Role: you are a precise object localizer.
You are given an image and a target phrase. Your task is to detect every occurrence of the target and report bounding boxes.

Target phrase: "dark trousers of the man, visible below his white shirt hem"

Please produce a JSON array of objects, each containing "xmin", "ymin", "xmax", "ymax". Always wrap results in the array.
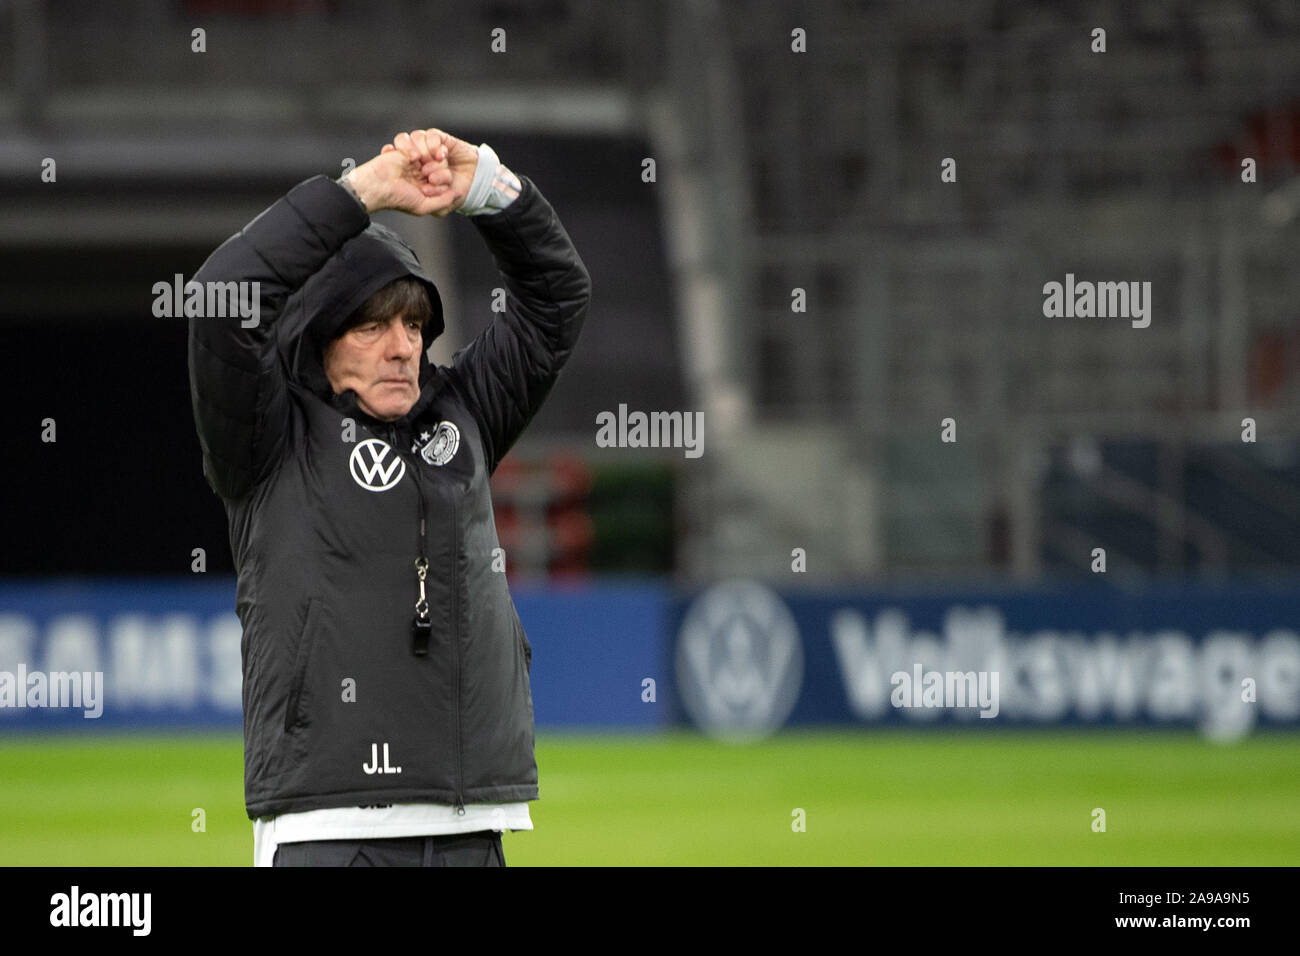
[{"xmin": 272, "ymin": 830, "xmax": 506, "ymax": 866}]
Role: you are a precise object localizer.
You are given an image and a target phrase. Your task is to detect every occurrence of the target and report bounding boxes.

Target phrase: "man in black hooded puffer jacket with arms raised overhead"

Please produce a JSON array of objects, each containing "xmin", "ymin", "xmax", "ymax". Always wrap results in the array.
[{"xmin": 187, "ymin": 130, "xmax": 590, "ymax": 865}]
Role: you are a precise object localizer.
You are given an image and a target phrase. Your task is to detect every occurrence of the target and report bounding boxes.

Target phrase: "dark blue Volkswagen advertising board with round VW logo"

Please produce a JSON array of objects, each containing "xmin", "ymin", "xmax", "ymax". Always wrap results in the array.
[{"xmin": 672, "ymin": 581, "xmax": 1300, "ymax": 739}]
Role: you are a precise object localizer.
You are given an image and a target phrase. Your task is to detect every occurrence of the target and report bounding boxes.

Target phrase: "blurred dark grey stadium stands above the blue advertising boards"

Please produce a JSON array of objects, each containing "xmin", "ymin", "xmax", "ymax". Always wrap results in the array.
[{"xmin": 0, "ymin": 0, "xmax": 1300, "ymax": 585}]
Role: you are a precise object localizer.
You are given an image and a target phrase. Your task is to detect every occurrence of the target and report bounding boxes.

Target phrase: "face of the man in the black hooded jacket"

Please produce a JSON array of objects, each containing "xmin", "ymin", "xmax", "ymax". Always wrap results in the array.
[{"xmin": 325, "ymin": 315, "xmax": 424, "ymax": 421}]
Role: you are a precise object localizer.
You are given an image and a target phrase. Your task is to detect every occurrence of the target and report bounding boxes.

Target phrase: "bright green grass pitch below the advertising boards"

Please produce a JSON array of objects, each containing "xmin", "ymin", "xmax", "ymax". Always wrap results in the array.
[{"xmin": 0, "ymin": 730, "xmax": 1300, "ymax": 866}]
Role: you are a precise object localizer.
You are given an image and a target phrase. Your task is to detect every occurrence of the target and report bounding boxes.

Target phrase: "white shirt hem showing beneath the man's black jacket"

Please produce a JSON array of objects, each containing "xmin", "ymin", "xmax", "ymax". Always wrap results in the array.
[{"xmin": 252, "ymin": 803, "xmax": 533, "ymax": 866}]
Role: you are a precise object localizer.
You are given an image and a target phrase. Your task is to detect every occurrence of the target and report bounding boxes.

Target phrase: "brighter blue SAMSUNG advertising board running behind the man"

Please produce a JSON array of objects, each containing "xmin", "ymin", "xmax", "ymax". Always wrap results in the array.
[{"xmin": 0, "ymin": 579, "xmax": 670, "ymax": 734}]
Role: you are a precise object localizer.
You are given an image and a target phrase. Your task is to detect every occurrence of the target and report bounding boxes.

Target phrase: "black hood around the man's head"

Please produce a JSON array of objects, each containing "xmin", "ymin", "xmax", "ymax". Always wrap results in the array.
[{"xmin": 277, "ymin": 222, "xmax": 446, "ymax": 401}]
